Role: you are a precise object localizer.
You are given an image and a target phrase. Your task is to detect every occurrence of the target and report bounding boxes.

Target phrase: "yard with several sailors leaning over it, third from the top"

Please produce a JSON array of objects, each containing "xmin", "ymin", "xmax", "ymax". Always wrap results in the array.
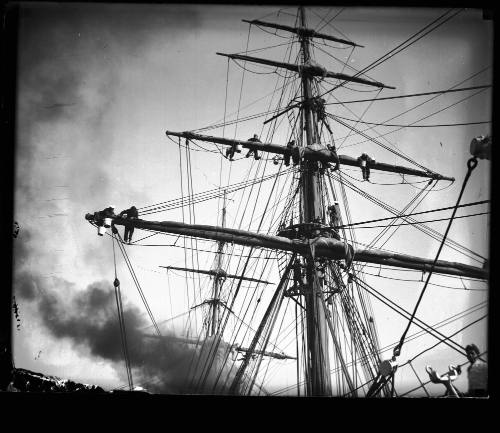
[{"xmin": 166, "ymin": 131, "xmax": 455, "ymax": 181}]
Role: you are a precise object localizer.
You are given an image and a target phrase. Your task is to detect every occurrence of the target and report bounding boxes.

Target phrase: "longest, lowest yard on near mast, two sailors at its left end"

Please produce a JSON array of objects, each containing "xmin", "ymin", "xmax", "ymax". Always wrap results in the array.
[{"xmin": 86, "ymin": 214, "xmax": 488, "ymax": 280}]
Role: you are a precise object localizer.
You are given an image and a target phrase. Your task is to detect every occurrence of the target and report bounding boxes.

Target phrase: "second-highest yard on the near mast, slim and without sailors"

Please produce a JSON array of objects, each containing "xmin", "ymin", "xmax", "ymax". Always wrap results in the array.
[{"xmin": 215, "ymin": 53, "xmax": 395, "ymax": 89}]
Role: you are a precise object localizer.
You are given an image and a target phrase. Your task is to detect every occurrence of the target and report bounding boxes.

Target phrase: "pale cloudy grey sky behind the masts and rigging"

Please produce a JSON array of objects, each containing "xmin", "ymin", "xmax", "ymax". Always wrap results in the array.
[{"xmin": 13, "ymin": 3, "xmax": 493, "ymax": 392}]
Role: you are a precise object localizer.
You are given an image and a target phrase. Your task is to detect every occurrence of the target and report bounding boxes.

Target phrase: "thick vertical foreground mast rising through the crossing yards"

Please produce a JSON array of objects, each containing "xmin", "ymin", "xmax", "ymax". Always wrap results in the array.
[{"xmin": 299, "ymin": 6, "xmax": 331, "ymax": 396}]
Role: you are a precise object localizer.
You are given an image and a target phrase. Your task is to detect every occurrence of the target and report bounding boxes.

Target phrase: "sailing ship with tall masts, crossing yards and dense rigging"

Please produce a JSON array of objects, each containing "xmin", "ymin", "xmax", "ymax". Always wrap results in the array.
[{"xmin": 85, "ymin": 7, "xmax": 488, "ymax": 397}]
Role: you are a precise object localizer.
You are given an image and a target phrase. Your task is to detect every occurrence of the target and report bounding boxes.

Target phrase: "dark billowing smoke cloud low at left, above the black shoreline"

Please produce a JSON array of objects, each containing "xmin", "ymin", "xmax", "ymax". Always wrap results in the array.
[{"xmin": 15, "ymin": 272, "xmax": 236, "ymax": 393}]
